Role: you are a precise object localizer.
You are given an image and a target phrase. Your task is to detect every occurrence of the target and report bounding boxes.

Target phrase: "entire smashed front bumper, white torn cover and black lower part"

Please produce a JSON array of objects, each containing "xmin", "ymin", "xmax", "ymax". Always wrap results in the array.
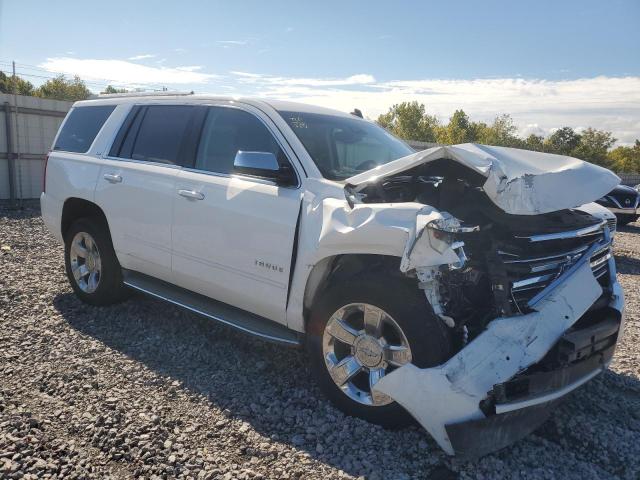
[{"xmin": 374, "ymin": 240, "xmax": 624, "ymax": 458}]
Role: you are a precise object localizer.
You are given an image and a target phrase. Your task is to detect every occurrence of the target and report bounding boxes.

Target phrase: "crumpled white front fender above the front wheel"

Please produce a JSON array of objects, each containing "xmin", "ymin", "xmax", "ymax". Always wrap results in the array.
[{"xmin": 287, "ymin": 181, "xmax": 460, "ymax": 331}]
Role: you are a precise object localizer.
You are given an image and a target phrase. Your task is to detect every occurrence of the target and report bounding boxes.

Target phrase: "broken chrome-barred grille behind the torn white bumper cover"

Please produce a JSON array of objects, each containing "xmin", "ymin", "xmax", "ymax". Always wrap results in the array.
[{"xmin": 498, "ymin": 221, "xmax": 611, "ymax": 311}]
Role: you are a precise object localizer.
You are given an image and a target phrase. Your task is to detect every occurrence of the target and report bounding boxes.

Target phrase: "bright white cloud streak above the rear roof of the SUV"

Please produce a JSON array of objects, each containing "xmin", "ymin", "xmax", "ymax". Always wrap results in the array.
[{"xmin": 40, "ymin": 57, "xmax": 218, "ymax": 86}]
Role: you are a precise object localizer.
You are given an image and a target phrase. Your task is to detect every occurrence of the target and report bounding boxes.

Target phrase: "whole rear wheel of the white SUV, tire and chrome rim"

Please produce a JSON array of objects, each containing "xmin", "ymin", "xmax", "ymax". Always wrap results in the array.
[{"xmin": 65, "ymin": 217, "xmax": 128, "ymax": 305}]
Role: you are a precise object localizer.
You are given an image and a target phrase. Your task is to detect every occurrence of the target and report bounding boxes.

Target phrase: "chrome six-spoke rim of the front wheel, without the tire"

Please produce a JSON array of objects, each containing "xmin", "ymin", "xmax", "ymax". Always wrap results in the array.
[{"xmin": 322, "ymin": 303, "xmax": 411, "ymax": 406}]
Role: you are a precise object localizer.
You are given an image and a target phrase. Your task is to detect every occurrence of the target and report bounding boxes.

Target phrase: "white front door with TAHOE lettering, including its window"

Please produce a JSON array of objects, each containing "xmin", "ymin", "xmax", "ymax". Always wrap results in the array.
[{"xmin": 173, "ymin": 106, "xmax": 301, "ymax": 323}]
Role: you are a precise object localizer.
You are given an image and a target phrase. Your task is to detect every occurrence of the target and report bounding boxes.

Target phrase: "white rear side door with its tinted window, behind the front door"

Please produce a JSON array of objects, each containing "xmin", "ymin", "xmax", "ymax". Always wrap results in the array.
[{"xmin": 95, "ymin": 105, "xmax": 202, "ymax": 281}]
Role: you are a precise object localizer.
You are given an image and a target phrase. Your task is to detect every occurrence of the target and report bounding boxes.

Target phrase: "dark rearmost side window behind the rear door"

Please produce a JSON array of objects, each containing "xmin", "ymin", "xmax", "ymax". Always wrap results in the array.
[{"xmin": 53, "ymin": 105, "xmax": 116, "ymax": 153}]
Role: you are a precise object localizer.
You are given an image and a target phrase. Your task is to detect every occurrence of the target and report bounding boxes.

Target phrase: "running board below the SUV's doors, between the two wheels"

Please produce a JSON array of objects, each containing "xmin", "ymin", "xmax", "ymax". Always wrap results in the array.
[{"xmin": 122, "ymin": 269, "xmax": 302, "ymax": 346}]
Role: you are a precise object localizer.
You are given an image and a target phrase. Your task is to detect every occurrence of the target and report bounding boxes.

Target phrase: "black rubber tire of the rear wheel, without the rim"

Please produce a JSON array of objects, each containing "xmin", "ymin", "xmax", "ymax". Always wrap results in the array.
[{"xmin": 64, "ymin": 217, "xmax": 129, "ymax": 306}]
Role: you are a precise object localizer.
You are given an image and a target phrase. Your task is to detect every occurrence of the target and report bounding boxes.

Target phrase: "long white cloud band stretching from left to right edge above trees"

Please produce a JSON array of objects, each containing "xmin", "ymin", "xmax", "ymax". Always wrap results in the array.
[{"xmin": 35, "ymin": 57, "xmax": 640, "ymax": 144}]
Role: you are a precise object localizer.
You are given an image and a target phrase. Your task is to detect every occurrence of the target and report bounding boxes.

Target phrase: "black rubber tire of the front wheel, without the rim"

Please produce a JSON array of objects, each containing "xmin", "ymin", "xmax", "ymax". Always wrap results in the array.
[{"xmin": 306, "ymin": 272, "xmax": 451, "ymax": 428}]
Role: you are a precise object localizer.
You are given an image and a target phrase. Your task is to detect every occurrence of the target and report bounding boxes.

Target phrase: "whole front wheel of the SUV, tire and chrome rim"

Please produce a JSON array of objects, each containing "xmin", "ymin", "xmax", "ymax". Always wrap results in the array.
[{"xmin": 307, "ymin": 274, "xmax": 451, "ymax": 428}]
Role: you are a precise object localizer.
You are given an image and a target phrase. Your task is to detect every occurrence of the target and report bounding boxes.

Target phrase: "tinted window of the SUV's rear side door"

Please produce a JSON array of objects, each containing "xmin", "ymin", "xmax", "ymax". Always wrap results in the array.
[{"xmin": 111, "ymin": 105, "xmax": 197, "ymax": 165}]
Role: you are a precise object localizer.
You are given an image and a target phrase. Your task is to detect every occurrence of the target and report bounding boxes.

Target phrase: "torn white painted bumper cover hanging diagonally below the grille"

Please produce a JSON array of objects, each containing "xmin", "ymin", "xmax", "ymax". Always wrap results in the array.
[{"xmin": 374, "ymin": 261, "xmax": 602, "ymax": 454}]
